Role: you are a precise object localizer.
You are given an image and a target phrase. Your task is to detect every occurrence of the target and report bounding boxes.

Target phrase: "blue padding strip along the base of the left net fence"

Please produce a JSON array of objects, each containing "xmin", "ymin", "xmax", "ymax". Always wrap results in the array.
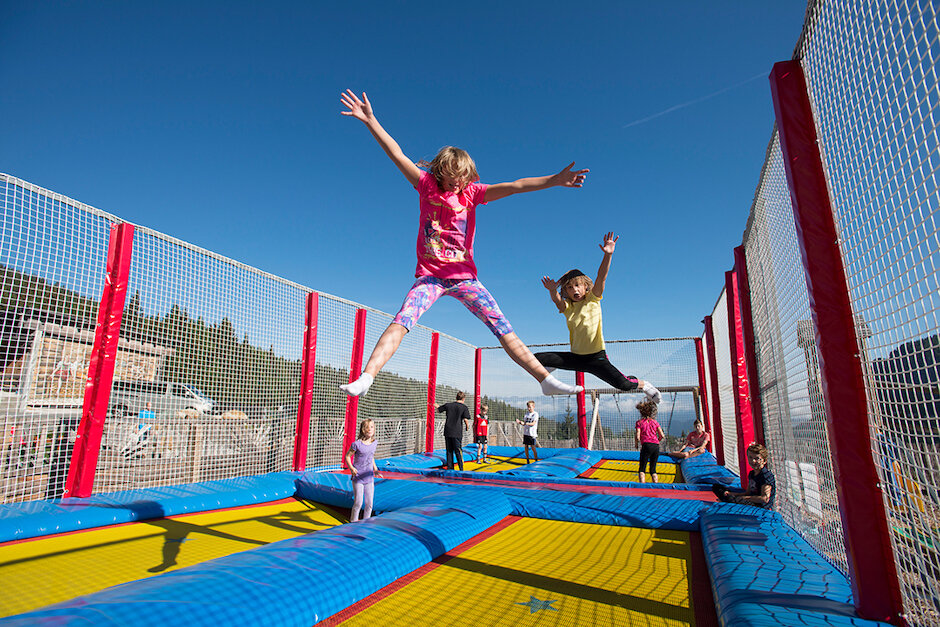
[{"xmin": 0, "ymin": 472, "xmax": 297, "ymax": 542}]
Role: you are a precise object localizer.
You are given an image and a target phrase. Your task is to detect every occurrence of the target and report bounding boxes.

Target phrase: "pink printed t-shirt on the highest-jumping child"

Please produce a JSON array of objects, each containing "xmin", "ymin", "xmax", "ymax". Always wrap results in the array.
[{"xmin": 415, "ymin": 172, "xmax": 487, "ymax": 279}]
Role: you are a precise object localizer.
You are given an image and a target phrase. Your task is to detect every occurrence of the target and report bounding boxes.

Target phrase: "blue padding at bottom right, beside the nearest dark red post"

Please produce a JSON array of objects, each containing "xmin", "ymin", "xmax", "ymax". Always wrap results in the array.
[{"xmin": 699, "ymin": 503, "xmax": 882, "ymax": 625}]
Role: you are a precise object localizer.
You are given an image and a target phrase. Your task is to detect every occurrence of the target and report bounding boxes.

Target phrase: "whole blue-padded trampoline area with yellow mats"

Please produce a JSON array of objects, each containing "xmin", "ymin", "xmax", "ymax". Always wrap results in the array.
[{"xmin": 0, "ymin": 449, "xmax": 892, "ymax": 627}]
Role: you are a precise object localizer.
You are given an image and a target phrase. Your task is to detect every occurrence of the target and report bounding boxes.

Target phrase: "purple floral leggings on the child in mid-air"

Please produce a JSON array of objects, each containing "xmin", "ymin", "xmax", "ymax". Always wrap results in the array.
[{"xmin": 393, "ymin": 276, "xmax": 512, "ymax": 337}]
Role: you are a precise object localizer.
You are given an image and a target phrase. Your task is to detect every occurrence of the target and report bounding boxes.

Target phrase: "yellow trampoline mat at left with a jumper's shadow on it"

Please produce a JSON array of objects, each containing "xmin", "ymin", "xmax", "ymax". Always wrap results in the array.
[{"xmin": 0, "ymin": 499, "xmax": 347, "ymax": 616}]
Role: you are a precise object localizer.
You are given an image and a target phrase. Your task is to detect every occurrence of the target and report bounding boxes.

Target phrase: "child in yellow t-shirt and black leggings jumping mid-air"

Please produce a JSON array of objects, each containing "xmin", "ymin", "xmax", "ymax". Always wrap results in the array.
[{"xmin": 535, "ymin": 232, "xmax": 662, "ymax": 403}]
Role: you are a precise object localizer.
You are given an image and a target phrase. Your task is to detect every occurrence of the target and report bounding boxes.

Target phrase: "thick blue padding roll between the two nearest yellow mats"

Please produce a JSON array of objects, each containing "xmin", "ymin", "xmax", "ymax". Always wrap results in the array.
[{"xmin": 0, "ymin": 488, "xmax": 510, "ymax": 627}]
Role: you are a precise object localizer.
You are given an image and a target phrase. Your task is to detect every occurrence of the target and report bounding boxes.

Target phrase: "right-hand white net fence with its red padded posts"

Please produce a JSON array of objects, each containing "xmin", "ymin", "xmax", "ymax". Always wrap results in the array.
[{"xmin": 703, "ymin": 0, "xmax": 940, "ymax": 625}]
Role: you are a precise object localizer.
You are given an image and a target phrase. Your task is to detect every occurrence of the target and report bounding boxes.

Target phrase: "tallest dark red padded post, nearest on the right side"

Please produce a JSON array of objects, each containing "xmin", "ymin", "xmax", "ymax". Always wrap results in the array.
[{"xmin": 770, "ymin": 61, "xmax": 906, "ymax": 625}]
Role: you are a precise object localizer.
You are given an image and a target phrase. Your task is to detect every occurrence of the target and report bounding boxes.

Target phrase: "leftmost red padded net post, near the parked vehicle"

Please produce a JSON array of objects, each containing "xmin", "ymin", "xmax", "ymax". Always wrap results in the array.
[{"xmin": 63, "ymin": 223, "xmax": 134, "ymax": 498}]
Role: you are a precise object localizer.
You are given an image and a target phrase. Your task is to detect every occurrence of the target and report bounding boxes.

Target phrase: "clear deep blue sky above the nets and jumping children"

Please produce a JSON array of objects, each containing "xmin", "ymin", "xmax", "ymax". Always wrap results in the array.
[{"xmin": 0, "ymin": 0, "xmax": 805, "ymax": 346}]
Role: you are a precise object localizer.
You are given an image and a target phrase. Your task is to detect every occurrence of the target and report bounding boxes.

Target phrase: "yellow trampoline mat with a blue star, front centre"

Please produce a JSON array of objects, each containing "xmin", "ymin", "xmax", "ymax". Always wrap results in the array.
[{"xmin": 342, "ymin": 518, "xmax": 695, "ymax": 627}]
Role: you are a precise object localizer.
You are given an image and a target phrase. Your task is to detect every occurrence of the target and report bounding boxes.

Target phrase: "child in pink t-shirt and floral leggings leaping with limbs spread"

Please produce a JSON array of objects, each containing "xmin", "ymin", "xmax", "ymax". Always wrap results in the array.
[{"xmin": 340, "ymin": 90, "xmax": 588, "ymax": 396}]
